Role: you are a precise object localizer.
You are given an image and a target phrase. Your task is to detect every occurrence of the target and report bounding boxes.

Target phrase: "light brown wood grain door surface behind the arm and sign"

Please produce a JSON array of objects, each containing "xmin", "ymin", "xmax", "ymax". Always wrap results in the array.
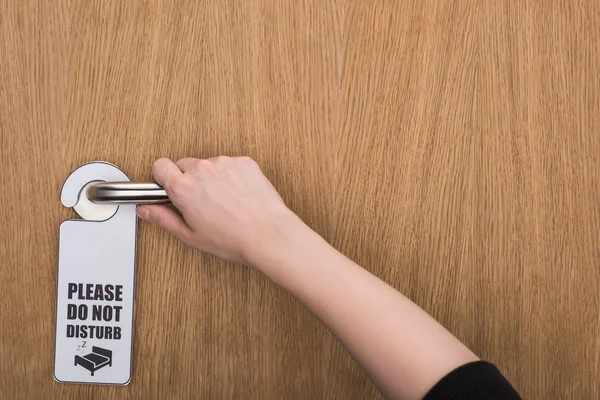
[{"xmin": 0, "ymin": 0, "xmax": 600, "ymax": 399}]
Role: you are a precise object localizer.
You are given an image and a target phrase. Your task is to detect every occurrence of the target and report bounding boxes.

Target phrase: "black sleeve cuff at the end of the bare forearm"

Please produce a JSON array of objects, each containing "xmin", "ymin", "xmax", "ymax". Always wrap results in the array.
[{"xmin": 423, "ymin": 361, "xmax": 521, "ymax": 400}]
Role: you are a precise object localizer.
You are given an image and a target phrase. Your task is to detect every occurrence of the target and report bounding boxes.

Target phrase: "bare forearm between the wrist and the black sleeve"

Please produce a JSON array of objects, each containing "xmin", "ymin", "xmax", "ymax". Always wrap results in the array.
[{"xmin": 248, "ymin": 219, "xmax": 477, "ymax": 399}]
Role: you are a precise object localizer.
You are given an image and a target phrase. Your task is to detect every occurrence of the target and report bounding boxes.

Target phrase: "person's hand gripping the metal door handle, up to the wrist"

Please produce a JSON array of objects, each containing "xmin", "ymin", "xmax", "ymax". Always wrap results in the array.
[{"xmin": 137, "ymin": 157, "xmax": 300, "ymax": 264}]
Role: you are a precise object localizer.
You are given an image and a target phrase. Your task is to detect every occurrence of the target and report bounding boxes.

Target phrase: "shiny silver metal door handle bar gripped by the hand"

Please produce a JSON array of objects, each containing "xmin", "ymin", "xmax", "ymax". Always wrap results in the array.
[{"xmin": 86, "ymin": 182, "xmax": 170, "ymax": 204}]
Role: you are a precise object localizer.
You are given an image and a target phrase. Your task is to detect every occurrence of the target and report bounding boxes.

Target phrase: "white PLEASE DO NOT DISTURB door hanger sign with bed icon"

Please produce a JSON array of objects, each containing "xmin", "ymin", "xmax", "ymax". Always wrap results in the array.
[{"xmin": 54, "ymin": 162, "xmax": 137, "ymax": 385}]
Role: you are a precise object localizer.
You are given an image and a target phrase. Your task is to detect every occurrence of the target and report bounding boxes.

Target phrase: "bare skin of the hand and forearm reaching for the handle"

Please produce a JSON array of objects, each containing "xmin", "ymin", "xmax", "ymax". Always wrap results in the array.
[{"xmin": 138, "ymin": 157, "xmax": 478, "ymax": 399}]
